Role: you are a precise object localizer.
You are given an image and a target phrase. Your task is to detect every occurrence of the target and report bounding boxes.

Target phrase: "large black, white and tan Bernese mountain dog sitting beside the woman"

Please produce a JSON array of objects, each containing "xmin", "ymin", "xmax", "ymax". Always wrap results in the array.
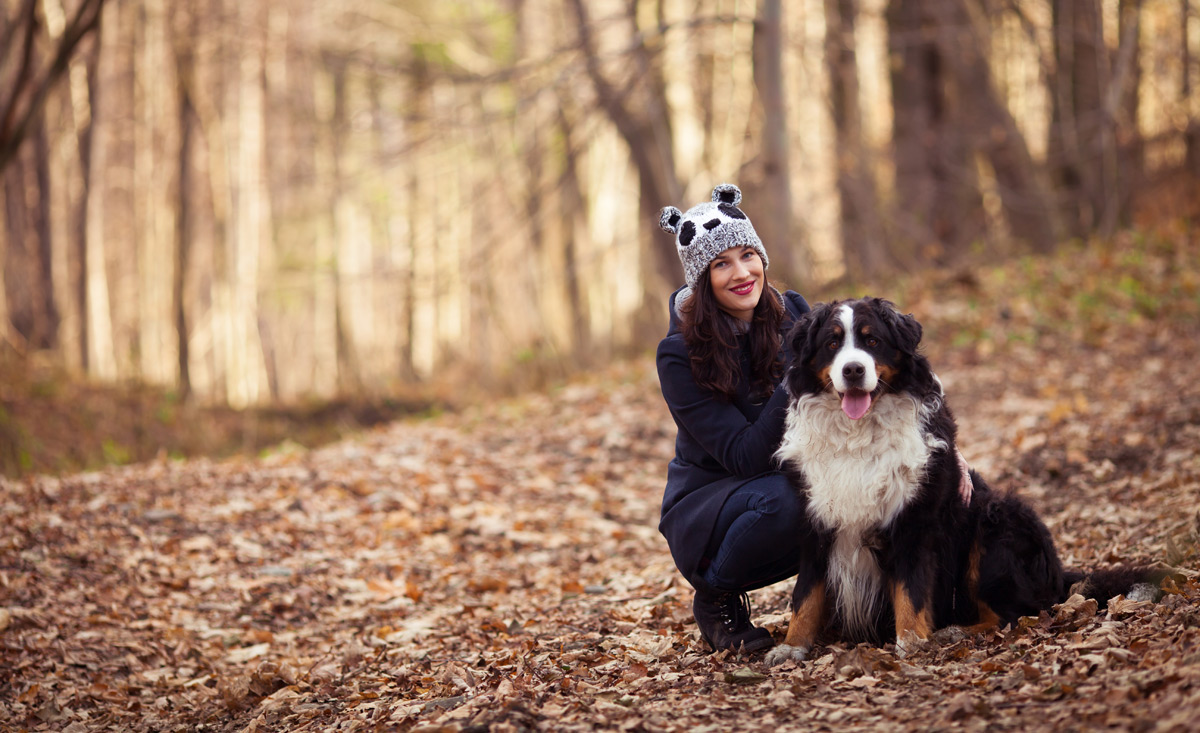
[{"xmin": 766, "ymin": 298, "xmax": 1160, "ymax": 665}]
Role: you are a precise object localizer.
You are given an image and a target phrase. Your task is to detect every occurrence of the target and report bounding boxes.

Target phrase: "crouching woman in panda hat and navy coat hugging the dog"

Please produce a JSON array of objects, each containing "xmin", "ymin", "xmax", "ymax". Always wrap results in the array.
[{"xmin": 658, "ymin": 184, "xmax": 811, "ymax": 651}]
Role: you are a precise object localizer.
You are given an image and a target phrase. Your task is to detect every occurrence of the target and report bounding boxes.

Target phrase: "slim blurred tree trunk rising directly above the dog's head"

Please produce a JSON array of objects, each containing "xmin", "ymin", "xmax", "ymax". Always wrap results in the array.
[{"xmin": 824, "ymin": 0, "xmax": 901, "ymax": 280}]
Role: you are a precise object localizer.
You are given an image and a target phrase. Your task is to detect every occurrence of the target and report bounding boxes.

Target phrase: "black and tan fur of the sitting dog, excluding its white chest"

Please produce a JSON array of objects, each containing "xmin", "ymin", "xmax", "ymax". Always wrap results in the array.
[{"xmin": 768, "ymin": 299, "xmax": 1160, "ymax": 663}]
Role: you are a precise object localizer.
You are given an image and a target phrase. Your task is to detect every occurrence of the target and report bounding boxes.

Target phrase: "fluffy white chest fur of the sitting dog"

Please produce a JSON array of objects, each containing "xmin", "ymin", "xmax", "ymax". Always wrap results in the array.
[{"xmin": 776, "ymin": 392, "xmax": 946, "ymax": 636}]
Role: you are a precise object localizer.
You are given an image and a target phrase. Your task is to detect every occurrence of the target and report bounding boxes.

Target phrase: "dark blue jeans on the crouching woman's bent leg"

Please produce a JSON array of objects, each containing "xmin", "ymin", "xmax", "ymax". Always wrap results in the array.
[{"xmin": 701, "ymin": 474, "xmax": 811, "ymax": 593}]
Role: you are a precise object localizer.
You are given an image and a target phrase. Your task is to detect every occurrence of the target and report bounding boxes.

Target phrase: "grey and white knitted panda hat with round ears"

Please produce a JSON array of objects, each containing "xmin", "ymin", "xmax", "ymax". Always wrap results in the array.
[{"xmin": 659, "ymin": 184, "xmax": 770, "ymax": 289}]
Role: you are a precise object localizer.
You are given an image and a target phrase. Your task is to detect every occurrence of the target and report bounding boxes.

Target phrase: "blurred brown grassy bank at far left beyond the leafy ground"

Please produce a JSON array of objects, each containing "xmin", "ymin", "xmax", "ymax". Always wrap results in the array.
[{"xmin": 0, "ymin": 357, "xmax": 455, "ymax": 477}]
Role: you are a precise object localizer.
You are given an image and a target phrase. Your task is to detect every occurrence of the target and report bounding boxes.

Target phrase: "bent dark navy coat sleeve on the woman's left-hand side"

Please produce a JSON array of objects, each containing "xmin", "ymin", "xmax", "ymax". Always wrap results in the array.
[{"xmin": 658, "ymin": 338, "xmax": 787, "ymax": 479}]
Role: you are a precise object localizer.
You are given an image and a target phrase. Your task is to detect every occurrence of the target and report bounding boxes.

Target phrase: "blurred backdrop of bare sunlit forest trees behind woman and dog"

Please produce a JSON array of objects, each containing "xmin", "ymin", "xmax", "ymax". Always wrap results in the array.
[{"xmin": 0, "ymin": 0, "xmax": 1200, "ymax": 405}]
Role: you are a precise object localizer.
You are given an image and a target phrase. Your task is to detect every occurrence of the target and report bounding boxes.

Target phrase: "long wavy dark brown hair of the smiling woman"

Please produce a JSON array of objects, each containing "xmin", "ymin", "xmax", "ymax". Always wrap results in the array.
[{"xmin": 679, "ymin": 261, "xmax": 784, "ymax": 401}]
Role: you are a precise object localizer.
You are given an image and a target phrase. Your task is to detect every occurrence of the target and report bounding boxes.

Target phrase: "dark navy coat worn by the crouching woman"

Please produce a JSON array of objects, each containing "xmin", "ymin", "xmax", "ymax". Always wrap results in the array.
[{"xmin": 658, "ymin": 284, "xmax": 810, "ymax": 590}]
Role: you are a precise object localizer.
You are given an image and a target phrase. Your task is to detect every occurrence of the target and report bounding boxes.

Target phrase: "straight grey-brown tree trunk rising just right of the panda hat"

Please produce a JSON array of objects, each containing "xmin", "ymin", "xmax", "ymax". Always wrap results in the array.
[{"xmin": 745, "ymin": 0, "xmax": 809, "ymax": 283}]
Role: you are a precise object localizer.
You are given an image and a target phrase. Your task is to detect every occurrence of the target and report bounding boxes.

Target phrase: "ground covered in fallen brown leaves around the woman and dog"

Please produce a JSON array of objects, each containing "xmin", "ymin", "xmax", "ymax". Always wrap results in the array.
[{"xmin": 0, "ymin": 230, "xmax": 1200, "ymax": 732}]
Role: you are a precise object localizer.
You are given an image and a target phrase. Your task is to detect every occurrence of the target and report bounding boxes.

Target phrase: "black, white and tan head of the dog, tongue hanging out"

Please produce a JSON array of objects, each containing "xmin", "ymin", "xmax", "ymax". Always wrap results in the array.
[{"xmin": 787, "ymin": 298, "xmax": 934, "ymax": 420}]
